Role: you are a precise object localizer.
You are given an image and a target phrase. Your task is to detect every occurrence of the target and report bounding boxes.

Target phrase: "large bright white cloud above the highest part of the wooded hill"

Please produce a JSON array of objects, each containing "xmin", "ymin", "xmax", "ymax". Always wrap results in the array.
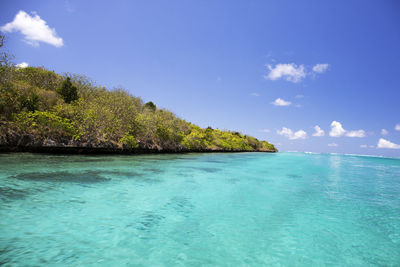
[{"xmin": 0, "ymin": 10, "xmax": 64, "ymax": 47}]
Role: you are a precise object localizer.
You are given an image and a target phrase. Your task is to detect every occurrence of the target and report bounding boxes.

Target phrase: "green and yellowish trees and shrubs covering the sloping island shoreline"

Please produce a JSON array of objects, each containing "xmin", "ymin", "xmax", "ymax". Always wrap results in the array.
[{"xmin": 0, "ymin": 34, "xmax": 276, "ymax": 151}]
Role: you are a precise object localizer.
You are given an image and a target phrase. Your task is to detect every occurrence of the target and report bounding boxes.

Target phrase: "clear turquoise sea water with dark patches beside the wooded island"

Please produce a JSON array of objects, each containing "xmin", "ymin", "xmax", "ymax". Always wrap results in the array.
[{"xmin": 0, "ymin": 153, "xmax": 400, "ymax": 266}]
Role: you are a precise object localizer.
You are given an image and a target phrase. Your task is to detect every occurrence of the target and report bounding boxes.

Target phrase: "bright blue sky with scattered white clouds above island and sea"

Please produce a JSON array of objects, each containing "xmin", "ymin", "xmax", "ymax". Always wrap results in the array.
[{"xmin": 0, "ymin": 0, "xmax": 400, "ymax": 157}]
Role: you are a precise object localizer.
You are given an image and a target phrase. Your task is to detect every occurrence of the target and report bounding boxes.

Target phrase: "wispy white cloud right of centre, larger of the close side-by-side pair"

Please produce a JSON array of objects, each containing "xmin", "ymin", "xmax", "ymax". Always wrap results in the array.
[{"xmin": 264, "ymin": 63, "xmax": 306, "ymax": 83}]
